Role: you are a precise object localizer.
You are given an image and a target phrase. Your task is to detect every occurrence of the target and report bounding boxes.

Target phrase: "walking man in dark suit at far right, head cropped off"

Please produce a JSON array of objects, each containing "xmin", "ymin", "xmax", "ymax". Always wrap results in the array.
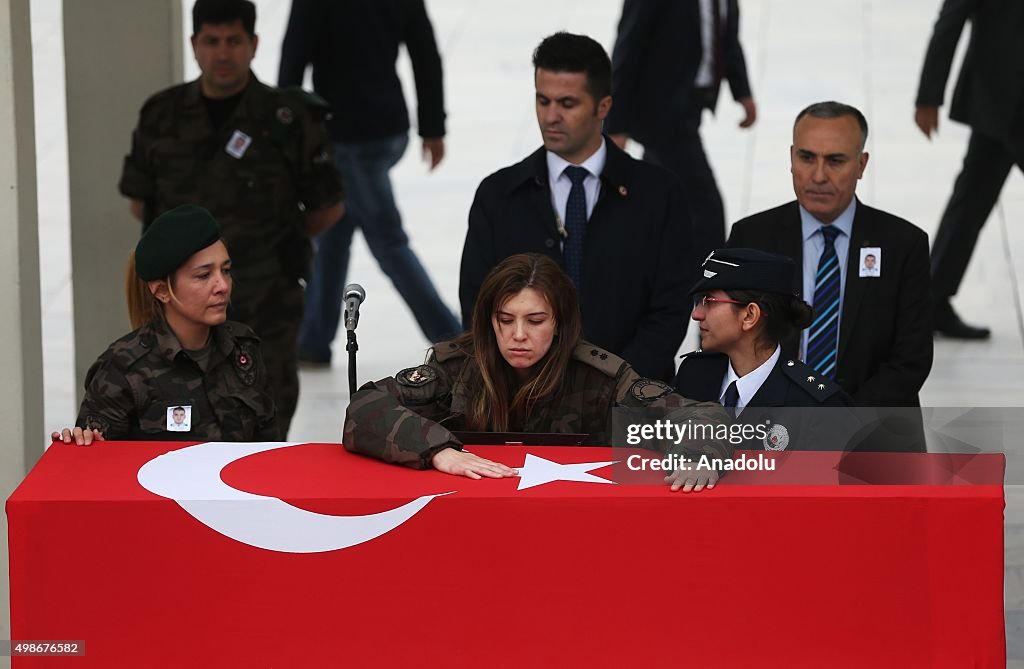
[{"xmin": 913, "ymin": 0, "xmax": 1024, "ymax": 339}]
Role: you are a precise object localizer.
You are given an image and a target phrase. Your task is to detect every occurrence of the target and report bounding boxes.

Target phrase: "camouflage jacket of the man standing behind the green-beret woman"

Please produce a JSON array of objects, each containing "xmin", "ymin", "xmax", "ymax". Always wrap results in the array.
[{"xmin": 119, "ymin": 75, "xmax": 342, "ymax": 279}]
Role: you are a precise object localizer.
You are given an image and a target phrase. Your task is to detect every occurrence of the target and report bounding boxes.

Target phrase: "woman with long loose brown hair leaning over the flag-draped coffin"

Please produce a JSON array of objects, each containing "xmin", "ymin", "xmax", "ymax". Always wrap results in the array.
[{"xmin": 342, "ymin": 253, "xmax": 732, "ymax": 492}]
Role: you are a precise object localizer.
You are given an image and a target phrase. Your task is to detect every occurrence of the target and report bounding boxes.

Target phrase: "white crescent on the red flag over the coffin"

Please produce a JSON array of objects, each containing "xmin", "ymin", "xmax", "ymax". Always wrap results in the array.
[{"xmin": 138, "ymin": 442, "xmax": 449, "ymax": 553}]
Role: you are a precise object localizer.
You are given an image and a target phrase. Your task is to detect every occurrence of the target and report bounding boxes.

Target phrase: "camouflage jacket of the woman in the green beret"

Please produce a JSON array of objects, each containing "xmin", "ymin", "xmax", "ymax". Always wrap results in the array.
[{"xmin": 75, "ymin": 319, "xmax": 280, "ymax": 442}]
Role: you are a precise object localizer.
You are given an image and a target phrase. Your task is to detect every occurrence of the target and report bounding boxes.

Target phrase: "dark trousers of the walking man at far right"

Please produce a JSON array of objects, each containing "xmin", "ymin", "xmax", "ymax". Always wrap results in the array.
[{"xmin": 932, "ymin": 130, "xmax": 1024, "ymax": 301}]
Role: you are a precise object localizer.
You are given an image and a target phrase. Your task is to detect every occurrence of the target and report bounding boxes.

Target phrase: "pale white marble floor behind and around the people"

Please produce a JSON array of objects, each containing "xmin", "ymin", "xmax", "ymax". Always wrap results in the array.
[{"xmin": 32, "ymin": 0, "xmax": 1024, "ymax": 667}]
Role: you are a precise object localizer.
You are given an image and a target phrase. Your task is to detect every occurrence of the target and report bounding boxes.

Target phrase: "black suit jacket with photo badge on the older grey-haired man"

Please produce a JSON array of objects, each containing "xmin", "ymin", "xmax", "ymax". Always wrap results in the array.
[{"xmin": 728, "ymin": 200, "xmax": 933, "ymax": 407}]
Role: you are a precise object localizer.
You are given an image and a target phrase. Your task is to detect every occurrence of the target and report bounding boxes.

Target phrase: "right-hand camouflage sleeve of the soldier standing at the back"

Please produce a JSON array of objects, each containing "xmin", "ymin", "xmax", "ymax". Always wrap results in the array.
[{"xmin": 289, "ymin": 91, "xmax": 344, "ymax": 211}]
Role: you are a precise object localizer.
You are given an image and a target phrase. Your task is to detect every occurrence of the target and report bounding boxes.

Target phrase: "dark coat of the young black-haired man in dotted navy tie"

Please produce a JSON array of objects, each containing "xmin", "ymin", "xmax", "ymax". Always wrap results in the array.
[{"xmin": 459, "ymin": 138, "xmax": 701, "ymax": 381}]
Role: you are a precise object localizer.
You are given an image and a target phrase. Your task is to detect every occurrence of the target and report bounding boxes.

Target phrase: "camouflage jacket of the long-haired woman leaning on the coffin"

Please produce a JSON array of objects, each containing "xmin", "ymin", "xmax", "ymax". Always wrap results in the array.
[{"xmin": 342, "ymin": 341, "xmax": 732, "ymax": 468}]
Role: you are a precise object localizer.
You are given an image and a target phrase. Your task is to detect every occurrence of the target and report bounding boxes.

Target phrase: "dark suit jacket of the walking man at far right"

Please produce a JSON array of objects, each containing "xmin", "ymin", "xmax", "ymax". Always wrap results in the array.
[{"xmin": 916, "ymin": 0, "xmax": 1024, "ymax": 139}]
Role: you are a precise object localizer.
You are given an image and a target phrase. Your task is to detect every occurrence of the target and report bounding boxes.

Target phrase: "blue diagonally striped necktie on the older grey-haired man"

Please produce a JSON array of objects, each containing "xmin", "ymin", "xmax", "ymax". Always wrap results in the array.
[{"xmin": 807, "ymin": 225, "xmax": 842, "ymax": 379}]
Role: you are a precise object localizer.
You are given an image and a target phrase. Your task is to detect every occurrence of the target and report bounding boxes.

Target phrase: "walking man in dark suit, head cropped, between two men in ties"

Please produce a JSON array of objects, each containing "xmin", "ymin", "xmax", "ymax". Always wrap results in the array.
[{"xmin": 606, "ymin": 0, "xmax": 757, "ymax": 258}]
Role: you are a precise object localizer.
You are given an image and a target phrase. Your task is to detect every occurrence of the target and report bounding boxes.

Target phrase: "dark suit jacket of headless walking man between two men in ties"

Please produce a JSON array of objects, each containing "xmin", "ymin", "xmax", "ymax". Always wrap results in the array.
[{"xmin": 604, "ymin": 0, "xmax": 751, "ymax": 143}]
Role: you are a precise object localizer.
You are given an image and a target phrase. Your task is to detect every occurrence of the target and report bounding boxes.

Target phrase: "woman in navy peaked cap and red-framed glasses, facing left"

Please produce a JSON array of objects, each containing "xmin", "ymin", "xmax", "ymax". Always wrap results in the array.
[{"xmin": 675, "ymin": 249, "xmax": 856, "ymax": 451}]
